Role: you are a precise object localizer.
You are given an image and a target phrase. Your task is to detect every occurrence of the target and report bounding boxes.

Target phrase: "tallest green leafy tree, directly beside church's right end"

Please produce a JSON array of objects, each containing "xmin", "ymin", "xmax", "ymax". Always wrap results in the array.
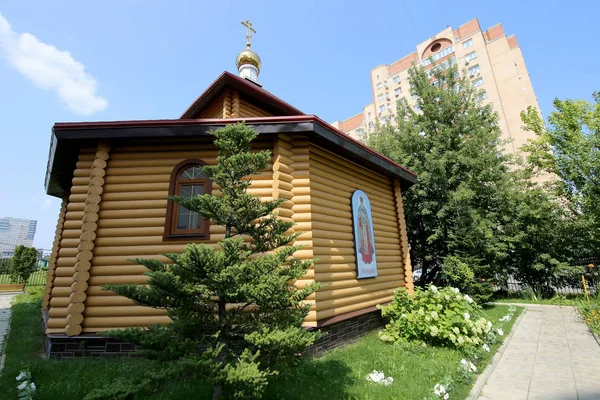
[{"xmin": 369, "ymin": 59, "xmax": 516, "ymax": 284}]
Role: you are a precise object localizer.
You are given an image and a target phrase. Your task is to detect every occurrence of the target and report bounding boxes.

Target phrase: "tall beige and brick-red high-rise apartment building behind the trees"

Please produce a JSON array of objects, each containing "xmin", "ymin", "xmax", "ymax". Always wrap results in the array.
[{"xmin": 332, "ymin": 19, "xmax": 539, "ymax": 153}]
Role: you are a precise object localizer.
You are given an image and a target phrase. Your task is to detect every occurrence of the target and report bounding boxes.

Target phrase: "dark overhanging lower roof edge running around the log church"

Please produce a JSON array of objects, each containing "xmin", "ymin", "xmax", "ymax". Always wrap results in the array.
[{"xmin": 45, "ymin": 115, "xmax": 416, "ymax": 197}]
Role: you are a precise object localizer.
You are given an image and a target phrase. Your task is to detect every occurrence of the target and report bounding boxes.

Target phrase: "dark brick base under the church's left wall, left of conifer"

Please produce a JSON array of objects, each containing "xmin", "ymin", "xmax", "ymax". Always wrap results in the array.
[{"xmin": 45, "ymin": 335, "xmax": 136, "ymax": 358}]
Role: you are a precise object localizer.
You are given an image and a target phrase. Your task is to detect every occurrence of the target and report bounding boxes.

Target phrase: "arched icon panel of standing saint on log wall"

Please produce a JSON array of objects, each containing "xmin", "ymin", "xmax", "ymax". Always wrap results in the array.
[{"xmin": 352, "ymin": 190, "xmax": 377, "ymax": 279}]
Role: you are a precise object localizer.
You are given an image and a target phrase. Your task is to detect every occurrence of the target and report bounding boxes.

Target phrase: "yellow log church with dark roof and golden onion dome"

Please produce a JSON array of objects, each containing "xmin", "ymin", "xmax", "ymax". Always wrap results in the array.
[{"xmin": 42, "ymin": 21, "xmax": 416, "ymax": 357}]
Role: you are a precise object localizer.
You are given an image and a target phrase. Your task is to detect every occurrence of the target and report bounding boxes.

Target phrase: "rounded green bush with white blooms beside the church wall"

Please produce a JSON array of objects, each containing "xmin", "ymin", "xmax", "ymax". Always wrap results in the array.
[{"xmin": 380, "ymin": 285, "xmax": 495, "ymax": 348}]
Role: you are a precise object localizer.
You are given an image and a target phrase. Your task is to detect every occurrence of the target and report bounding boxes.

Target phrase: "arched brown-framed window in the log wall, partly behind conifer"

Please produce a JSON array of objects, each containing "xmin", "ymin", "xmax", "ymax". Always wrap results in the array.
[{"xmin": 164, "ymin": 159, "xmax": 212, "ymax": 240}]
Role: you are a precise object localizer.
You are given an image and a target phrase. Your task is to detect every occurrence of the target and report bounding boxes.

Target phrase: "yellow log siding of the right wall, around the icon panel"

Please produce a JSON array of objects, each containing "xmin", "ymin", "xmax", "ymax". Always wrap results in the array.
[{"xmin": 309, "ymin": 145, "xmax": 405, "ymax": 320}]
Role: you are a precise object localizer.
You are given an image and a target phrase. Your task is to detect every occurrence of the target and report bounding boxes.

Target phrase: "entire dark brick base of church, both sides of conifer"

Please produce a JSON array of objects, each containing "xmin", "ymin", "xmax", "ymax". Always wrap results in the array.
[{"xmin": 44, "ymin": 310, "xmax": 385, "ymax": 358}]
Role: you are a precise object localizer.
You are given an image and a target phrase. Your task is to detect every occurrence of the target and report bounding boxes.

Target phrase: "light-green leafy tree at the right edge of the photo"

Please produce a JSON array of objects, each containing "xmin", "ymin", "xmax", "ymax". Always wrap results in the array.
[{"xmin": 521, "ymin": 92, "xmax": 600, "ymax": 256}]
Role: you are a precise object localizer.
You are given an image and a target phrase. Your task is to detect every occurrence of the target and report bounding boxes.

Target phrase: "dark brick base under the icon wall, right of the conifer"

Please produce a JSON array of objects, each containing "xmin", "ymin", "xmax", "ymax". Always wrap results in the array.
[{"xmin": 307, "ymin": 310, "xmax": 386, "ymax": 355}]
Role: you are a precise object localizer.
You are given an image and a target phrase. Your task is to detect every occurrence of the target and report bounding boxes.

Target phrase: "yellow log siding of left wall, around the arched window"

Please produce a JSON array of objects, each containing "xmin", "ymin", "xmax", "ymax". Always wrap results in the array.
[{"xmin": 47, "ymin": 138, "xmax": 276, "ymax": 333}]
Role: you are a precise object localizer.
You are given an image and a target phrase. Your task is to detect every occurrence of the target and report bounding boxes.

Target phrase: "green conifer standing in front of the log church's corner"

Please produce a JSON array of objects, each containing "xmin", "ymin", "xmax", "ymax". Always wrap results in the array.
[{"xmin": 88, "ymin": 124, "xmax": 318, "ymax": 399}]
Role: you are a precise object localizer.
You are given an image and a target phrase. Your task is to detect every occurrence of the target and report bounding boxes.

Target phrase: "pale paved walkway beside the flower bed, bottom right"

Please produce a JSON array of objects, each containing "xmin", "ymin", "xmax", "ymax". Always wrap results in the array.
[{"xmin": 479, "ymin": 305, "xmax": 600, "ymax": 400}]
